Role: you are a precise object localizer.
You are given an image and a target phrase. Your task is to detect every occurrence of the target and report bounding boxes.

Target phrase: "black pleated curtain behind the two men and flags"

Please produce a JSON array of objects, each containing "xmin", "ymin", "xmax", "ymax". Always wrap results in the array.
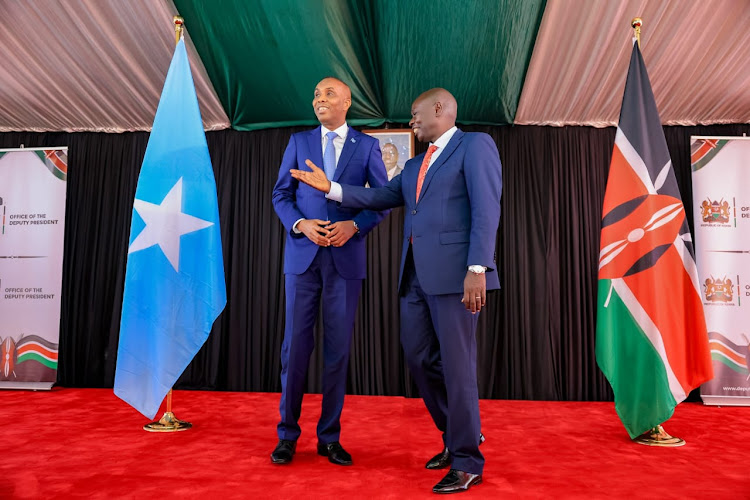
[{"xmin": 0, "ymin": 125, "xmax": 750, "ymax": 401}]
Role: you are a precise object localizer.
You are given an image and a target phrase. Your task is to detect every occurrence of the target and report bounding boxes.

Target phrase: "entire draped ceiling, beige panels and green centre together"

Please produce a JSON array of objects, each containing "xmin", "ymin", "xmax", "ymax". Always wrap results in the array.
[{"xmin": 0, "ymin": 0, "xmax": 750, "ymax": 133}]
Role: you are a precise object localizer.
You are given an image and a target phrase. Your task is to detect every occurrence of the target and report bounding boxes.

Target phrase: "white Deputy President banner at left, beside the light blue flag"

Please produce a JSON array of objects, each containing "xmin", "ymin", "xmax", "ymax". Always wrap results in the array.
[{"xmin": 0, "ymin": 148, "xmax": 68, "ymax": 389}]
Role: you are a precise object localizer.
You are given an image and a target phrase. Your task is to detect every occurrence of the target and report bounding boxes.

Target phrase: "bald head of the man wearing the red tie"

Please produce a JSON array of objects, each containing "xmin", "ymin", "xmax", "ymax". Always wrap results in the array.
[{"xmin": 409, "ymin": 88, "xmax": 458, "ymax": 142}]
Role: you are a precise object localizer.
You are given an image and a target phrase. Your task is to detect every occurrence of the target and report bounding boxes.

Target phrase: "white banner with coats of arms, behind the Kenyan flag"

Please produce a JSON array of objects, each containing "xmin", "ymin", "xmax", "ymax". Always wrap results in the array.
[{"xmin": 691, "ymin": 137, "xmax": 750, "ymax": 405}]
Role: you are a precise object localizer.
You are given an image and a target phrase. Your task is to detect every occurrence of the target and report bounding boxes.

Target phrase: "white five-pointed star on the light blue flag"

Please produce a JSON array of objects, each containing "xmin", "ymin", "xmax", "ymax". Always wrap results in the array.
[{"xmin": 128, "ymin": 177, "xmax": 214, "ymax": 271}]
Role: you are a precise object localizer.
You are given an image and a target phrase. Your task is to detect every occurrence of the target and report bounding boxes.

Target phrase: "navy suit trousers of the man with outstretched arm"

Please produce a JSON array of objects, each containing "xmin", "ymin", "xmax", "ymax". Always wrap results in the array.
[{"xmin": 400, "ymin": 245, "xmax": 484, "ymax": 474}]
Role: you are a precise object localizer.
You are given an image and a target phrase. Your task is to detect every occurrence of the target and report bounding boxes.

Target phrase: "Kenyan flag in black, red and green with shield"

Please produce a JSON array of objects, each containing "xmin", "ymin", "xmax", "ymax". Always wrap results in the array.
[{"xmin": 596, "ymin": 43, "xmax": 713, "ymax": 438}]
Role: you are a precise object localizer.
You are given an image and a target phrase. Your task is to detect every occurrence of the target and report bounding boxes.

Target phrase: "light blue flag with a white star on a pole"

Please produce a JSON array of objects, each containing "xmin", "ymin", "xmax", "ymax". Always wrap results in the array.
[{"xmin": 115, "ymin": 40, "xmax": 227, "ymax": 418}]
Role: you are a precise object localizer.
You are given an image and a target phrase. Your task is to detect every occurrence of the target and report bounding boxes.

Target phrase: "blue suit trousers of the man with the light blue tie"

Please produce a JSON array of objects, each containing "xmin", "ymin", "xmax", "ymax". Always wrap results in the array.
[{"xmin": 277, "ymin": 247, "xmax": 362, "ymax": 444}]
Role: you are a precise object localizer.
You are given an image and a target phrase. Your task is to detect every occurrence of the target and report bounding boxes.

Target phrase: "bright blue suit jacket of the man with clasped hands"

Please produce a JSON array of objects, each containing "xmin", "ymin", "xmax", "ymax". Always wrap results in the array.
[{"xmin": 273, "ymin": 127, "xmax": 388, "ymax": 279}]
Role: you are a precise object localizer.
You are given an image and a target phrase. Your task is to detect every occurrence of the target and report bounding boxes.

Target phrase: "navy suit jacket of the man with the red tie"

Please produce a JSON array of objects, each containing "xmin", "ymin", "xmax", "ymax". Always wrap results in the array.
[{"xmin": 341, "ymin": 130, "xmax": 502, "ymax": 295}]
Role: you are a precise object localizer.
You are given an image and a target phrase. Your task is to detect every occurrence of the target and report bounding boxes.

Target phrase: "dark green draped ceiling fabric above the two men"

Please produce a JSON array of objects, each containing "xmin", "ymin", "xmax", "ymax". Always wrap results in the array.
[{"xmin": 175, "ymin": 0, "xmax": 545, "ymax": 130}]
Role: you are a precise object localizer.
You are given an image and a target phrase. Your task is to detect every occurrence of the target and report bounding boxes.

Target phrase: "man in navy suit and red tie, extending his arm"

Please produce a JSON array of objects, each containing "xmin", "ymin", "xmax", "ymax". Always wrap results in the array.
[{"xmin": 291, "ymin": 89, "xmax": 502, "ymax": 493}]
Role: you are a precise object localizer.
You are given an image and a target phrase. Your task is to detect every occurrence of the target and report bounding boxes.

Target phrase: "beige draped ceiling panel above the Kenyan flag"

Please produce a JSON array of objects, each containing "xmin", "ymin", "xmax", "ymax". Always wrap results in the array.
[{"xmin": 515, "ymin": 0, "xmax": 750, "ymax": 127}]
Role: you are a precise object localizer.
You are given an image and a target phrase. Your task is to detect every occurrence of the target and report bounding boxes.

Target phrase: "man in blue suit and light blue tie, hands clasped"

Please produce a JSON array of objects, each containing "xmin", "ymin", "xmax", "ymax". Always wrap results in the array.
[{"xmin": 271, "ymin": 78, "xmax": 387, "ymax": 465}]
